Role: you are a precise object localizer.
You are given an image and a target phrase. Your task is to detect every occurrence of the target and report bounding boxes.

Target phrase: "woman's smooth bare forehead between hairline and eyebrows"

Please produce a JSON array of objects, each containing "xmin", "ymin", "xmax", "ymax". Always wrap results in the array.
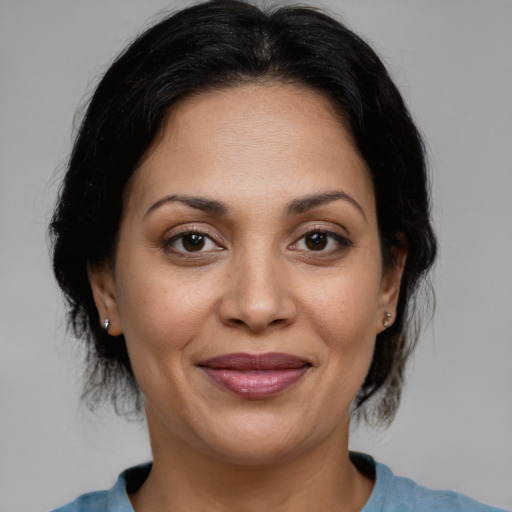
[{"xmin": 122, "ymin": 83, "xmax": 373, "ymax": 218}]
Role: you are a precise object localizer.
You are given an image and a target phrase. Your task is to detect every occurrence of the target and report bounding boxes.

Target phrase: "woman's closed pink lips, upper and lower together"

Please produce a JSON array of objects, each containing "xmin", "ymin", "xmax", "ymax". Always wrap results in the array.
[{"xmin": 199, "ymin": 352, "xmax": 311, "ymax": 398}]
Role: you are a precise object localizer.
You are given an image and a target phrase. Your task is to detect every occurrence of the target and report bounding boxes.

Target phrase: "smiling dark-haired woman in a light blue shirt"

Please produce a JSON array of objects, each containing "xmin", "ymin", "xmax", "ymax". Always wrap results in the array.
[{"xmin": 52, "ymin": 1, "xmax": 506, "ymax": 512}]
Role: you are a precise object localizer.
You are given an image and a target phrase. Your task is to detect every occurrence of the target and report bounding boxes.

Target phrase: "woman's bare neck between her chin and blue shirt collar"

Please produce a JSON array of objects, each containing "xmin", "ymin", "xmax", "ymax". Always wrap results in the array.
[{"xmin": 130, "ymin": 418, "xmax": 373, "ymax": 512}]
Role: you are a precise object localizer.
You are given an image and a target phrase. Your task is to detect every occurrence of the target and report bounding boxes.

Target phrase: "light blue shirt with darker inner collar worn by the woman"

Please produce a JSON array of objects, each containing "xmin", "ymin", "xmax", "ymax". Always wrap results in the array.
[{"xmin": 53, "ymin": 454, "xmax": 506, "ymax": 512}]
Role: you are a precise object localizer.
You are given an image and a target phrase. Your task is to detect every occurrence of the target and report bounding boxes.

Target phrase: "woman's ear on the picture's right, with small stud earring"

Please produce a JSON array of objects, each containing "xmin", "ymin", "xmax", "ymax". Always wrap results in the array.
[{"xmin": 376, "ymin": 246, "xmax": 407, "ymax": 334}]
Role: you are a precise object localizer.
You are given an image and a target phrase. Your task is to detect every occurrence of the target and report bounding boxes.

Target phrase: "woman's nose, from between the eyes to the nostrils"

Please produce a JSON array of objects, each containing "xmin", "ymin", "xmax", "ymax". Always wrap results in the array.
[{"xmin": 218, "ymin": 247, "xmax": 297, "ymax": 333}]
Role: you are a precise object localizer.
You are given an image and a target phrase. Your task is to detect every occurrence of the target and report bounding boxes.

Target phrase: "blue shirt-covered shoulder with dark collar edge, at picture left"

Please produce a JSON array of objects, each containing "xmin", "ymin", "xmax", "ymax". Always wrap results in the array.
[{"xmin": 52, "ymin": 464, "xmax": 151, "ymax": 512}]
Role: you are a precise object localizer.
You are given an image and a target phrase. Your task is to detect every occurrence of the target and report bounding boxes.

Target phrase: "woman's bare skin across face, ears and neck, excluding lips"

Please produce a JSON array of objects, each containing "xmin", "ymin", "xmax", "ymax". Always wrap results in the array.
[{"xmin": 90, "ymin": 83, "xmax": 405, "ymax": 512}]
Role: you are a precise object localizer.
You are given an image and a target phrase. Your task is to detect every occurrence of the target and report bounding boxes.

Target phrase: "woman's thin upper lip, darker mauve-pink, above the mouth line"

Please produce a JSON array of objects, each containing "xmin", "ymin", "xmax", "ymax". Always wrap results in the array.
[{"xmin": 199, "ymin": 352, "xmax": 311, "ymax": 371}]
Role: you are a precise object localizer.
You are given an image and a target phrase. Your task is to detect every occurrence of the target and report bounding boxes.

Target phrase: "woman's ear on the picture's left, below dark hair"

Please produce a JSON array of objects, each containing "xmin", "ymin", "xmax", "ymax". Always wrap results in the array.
[{"xmin": 87, "ymin": 265, "xmax": 123, "ymax": 336}]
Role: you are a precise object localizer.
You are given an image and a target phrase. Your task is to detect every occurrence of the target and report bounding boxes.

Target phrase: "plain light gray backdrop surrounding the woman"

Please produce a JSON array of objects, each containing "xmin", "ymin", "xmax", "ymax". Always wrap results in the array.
[{"xmin": 0, "ymin": 0, "xmax": 512, "ymax": 512}]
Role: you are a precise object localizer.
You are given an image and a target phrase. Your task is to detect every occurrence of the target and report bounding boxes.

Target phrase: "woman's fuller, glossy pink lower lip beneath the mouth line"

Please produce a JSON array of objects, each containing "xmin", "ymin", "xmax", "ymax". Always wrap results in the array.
[{"xmin": 201, "ymin": 366, "xmax": 309, "ymax": 398}]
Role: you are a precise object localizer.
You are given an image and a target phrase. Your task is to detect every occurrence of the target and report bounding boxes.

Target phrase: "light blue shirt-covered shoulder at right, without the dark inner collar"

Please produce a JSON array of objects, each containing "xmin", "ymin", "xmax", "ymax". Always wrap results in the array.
[{"xmin": 362, "ymin": 456, "xmax": 505, "ymax": 512}]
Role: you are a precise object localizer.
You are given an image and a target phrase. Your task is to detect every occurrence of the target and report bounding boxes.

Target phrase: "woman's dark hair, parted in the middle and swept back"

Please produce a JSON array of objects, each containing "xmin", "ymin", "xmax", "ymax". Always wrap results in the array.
[{"xmin": 51, "ymin": 0, "xmax": 436, "ymax": 421}]
